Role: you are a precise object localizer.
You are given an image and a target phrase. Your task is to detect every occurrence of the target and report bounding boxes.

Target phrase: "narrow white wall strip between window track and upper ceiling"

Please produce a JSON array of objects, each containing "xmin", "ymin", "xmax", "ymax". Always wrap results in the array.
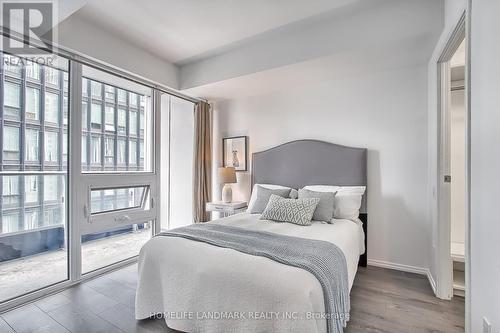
[{"xmin": 56, "ymin": 12, "xmax": 179, "ymax": 89}]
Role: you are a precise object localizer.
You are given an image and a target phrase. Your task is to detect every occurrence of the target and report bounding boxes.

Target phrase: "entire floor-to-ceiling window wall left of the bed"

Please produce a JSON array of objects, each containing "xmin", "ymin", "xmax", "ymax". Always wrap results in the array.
[{"xmin": 0, "ymin": 36, "xmax": 194, "ymax": 310}]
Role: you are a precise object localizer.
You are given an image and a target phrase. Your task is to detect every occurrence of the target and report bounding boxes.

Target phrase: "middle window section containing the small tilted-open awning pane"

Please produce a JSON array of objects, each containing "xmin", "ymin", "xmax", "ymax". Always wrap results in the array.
[{"xmin": 81, "ymin": 66, "xmax": 156, "ymax": 274}]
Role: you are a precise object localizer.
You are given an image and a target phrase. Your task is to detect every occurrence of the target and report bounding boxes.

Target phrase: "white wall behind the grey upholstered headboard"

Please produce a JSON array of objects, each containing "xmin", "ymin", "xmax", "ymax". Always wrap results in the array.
[{"xmin": 213, "ymin": 66, "xmax": 431, "ymax": 270}]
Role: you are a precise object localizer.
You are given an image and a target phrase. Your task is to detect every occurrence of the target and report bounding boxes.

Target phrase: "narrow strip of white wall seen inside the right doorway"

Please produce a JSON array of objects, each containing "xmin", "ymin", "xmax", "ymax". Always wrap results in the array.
[{"xmin": 450, "ymin": 90, "xmax": 466, "ymax": 245}]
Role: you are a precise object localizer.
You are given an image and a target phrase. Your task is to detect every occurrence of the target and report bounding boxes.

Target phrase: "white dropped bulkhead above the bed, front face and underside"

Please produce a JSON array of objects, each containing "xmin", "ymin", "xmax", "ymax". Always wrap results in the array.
[{"xmin": 180, "ymin": 0, "xmax": 443, "ymax": 100}]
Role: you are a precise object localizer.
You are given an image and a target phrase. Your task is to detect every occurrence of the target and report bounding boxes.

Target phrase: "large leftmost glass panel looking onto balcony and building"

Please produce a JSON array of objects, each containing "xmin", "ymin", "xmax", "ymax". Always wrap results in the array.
[{"xmin": 0, "ymin": 53, "xmax": 69, "ymax": 303}]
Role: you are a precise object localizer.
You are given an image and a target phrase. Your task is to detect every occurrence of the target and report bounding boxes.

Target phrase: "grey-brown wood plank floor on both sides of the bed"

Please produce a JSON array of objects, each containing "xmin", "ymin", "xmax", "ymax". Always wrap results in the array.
[{"xmin": 0, "ymin": 265, "xmax": 465, "ymax": 333}]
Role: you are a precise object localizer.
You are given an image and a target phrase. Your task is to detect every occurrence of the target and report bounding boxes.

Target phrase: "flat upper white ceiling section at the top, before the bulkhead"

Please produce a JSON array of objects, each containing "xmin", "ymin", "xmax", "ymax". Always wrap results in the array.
[{"xmin": 74, "ymin": 0, "xmax": 363, "ymax": 64}]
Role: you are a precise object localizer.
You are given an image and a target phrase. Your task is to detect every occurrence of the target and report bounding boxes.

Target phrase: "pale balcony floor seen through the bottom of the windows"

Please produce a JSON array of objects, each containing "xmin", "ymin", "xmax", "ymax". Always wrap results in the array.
[{"xmin": 0, "ymin": 229, "xmax": 151, "ymax": 302}]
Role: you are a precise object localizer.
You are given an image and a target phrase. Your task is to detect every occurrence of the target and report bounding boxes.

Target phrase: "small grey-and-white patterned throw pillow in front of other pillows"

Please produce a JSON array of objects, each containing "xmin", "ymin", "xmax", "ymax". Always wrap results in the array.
[{"xmin": 260, "ymin": 194, "xmax": 319, "ymax": 225}]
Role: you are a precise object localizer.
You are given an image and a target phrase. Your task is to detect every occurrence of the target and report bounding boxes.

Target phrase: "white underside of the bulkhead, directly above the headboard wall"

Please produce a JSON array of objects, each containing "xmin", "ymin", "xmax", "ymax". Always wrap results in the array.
[{"xmin": 183, "ymin": 34, "xmax": 438, "ymax": 101}]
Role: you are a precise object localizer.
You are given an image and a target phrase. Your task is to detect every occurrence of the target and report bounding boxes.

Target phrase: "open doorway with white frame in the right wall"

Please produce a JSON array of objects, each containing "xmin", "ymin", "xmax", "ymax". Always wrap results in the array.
[{"xmin": 437, "ymin": 13, "xmax": 470, "ymax": 327}]
